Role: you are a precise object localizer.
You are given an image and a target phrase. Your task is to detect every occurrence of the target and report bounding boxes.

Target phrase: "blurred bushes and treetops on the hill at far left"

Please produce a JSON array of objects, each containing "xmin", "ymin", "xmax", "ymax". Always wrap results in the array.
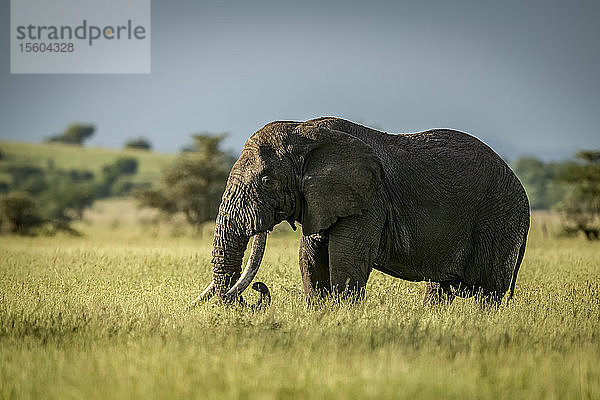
[{"xmin": 0, "ymin": 123, "xmax": 151, "ymax": 235}]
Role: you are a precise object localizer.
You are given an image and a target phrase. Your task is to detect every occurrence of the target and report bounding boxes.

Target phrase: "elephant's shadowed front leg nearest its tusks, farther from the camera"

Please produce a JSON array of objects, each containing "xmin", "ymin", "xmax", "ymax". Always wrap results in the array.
[{"xmin": 299, "ymin": 233, "xmax": 331, "ymax": 303}]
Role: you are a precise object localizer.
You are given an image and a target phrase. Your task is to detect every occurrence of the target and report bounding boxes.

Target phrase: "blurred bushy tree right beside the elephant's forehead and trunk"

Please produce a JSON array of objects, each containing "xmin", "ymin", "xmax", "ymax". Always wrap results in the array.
[{"xmin": 135, "ymin": 133, "xmax": 234, "ymax": 229}]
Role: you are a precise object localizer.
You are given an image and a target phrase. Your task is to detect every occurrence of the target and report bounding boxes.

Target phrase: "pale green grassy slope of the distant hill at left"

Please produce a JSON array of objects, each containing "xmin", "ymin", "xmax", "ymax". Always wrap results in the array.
[{"xmin": 0, "ymin": 140, "xmax": 175, "ymax": 182}]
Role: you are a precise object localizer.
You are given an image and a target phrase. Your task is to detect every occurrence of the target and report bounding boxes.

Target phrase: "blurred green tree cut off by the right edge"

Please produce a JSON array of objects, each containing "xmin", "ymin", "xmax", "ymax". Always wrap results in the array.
[{"xmin": 559, "ymin": 150, "xmax": 600, "ymax": 240}]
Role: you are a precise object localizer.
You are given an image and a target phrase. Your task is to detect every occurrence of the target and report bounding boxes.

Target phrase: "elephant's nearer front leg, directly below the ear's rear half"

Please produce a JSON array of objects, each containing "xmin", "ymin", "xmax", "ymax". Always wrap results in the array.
[{"xmin": 329, "ymin": 214, "xmax": 381, "ymax": 299}]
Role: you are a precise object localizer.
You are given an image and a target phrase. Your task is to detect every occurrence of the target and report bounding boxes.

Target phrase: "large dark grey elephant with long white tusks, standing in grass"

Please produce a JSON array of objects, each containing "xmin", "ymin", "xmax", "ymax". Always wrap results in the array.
[{"xmin": 193, "ymin": 117, "xmax": 529, "ymax": 303}]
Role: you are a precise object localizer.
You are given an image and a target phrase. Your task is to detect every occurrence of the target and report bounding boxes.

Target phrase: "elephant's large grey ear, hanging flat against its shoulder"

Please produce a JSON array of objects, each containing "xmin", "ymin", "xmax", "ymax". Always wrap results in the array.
[{"xmin": 301, "ymin": 128, "xmax": 383, "ymax": 235}]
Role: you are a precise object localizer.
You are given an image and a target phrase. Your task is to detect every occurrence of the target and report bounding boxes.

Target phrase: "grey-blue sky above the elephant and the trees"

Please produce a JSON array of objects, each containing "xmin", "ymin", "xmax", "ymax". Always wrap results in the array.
[{"xmin": 0, "ymin": 0, "xmax": 600, "ymax": 159}]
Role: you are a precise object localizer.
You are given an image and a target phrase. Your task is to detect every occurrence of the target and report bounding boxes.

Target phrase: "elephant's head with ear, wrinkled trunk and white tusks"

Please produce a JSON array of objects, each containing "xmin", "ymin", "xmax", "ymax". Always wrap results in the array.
[{"xmin": 190, "ymin": 119, "xmax": 383, "ymax": 301}]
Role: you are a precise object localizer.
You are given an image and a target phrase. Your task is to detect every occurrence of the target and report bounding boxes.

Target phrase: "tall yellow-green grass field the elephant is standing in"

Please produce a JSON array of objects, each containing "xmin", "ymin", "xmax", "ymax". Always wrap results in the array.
[{"xmin": 0, "ymin": 201, "xmax": 600, "ymax": 399}]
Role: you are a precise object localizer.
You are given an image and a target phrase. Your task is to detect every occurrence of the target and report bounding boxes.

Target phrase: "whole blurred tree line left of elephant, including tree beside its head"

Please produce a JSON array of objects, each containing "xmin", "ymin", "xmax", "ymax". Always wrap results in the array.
[{"xmin": 0, "ymin": 124, "xmax": 235, "ymax": 234}]
